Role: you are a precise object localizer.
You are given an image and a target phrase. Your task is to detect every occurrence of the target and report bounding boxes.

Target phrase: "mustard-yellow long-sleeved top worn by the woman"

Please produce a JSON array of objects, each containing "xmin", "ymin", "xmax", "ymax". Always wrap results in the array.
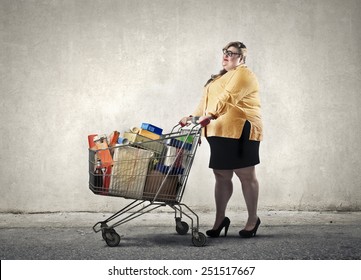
[{"xmin": 193, "ymin": 64, "xmax": 263, "ymax": 141}]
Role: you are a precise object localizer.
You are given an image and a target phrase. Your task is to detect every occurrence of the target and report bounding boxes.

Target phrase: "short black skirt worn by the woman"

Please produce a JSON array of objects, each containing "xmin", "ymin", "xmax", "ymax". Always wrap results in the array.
[{"xmin": 207, "ymin": 121, "xmax": 260, "ymax": 170}]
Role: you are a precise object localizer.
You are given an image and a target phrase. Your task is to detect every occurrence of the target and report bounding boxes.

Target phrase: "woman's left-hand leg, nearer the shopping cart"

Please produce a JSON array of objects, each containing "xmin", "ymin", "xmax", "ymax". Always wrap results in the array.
[{"xmin": 213, "ymin": 169, "xmax": 233, "ymax": 229}]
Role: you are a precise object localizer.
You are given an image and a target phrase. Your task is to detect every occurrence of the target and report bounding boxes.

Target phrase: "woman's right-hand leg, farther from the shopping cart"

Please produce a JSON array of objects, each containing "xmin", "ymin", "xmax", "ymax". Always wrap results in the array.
[{"xmin": 234, "ymin": 166, "xmax": 259, "ymax": 230}]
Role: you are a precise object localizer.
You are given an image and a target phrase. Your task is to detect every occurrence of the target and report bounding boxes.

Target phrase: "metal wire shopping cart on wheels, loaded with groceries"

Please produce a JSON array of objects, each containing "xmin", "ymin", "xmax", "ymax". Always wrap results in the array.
[{"xmin": 89, "ymin": 123, "xmax": 206, "ymax": 247}]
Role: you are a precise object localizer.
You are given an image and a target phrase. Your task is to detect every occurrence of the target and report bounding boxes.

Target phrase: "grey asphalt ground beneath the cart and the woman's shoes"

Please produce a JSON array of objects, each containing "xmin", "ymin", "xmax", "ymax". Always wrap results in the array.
[{"xmin": 0, "ymin": 211, "xmax": 361, "ymax": 260}]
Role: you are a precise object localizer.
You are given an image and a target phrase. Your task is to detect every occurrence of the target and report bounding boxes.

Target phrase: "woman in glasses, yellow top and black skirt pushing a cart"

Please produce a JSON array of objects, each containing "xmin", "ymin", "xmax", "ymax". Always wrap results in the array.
[{"xmin": 180, "ymin": 42, "xmax": 263, "ymax": 237}]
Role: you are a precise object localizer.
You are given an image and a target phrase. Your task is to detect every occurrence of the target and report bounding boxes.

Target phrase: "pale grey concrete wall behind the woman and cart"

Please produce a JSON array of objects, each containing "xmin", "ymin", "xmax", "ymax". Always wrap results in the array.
[{"xmin": 0, "ymin": 0, "xmax": 361, "ymax": 212}]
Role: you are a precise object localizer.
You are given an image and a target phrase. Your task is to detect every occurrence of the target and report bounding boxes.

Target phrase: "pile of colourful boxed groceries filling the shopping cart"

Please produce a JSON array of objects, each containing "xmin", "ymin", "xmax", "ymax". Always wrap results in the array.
[{"xmin": 88, "ymin": 123, "xmax": 197, "ymax": 201}]
